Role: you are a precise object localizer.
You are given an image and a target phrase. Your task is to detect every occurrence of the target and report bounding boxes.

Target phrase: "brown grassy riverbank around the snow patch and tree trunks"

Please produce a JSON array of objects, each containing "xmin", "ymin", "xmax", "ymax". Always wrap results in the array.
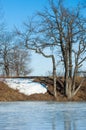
[{"xmin": 0, "ymin": 77, "xmax": 86, "ymax": 102}]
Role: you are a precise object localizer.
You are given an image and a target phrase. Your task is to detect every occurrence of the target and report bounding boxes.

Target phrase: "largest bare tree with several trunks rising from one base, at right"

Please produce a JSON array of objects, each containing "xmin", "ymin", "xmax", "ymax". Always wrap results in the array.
[{"xmin": 38, "ymin": 0, "xmax": 86, "ymax": 98}]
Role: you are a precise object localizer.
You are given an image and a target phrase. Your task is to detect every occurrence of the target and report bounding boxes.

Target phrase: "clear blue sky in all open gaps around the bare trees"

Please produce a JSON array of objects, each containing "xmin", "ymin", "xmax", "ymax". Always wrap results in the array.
[{"xmin": 0, "ymin": 0, "xmax": 84, "ymax": 75}]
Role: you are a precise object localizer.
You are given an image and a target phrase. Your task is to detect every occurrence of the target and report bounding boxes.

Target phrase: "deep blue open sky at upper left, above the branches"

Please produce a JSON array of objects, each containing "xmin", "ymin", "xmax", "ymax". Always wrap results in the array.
[{"xmin": 1, "ymin": 0, "xmax": 47, "ymax": 28}]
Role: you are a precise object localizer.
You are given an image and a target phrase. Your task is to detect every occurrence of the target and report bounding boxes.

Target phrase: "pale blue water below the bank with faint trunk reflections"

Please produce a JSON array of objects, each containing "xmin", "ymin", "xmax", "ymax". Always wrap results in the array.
[{"xmin": 0, "ymin": 102, "xmax": 86, "ymax": 130}]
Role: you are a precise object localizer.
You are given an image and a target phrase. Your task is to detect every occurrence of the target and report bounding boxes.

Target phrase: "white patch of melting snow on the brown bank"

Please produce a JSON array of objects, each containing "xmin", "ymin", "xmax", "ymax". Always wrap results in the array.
[{"xmin": 4, "ymin": 78, "xmax": 47, "ymax": 95}]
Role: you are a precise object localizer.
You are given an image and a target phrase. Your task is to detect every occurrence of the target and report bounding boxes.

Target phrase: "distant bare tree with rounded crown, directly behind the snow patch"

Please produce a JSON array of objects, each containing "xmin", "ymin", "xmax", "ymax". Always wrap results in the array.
[{"xmin": 10, "ymin": 46, "xmax": 32, "ymax": 76}]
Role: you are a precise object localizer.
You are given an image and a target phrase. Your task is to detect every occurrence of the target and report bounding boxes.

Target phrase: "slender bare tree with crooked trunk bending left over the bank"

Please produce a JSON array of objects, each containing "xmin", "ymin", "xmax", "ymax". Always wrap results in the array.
[{"xmin": 16, "ymin": 20, "xmax": 57, "ymax": 98}]
